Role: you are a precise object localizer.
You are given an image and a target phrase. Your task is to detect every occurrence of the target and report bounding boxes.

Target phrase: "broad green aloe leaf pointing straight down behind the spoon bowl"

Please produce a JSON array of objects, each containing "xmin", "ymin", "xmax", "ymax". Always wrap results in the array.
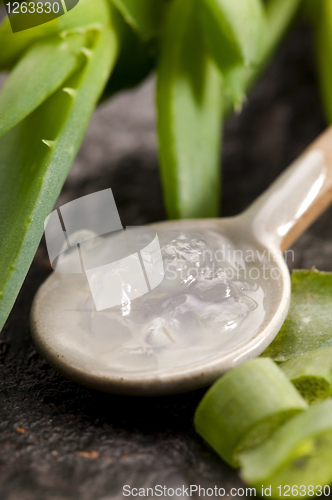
[{"xmin": 156, "ymin": 0, "xmax": 222, "ymax": 219}]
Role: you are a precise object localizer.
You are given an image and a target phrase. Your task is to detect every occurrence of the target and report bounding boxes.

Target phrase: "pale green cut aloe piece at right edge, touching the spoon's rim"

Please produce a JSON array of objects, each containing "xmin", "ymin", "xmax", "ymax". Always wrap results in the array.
[{"xmin": 262, "ymin": 270, "xmax": 332, "ymax": 361}]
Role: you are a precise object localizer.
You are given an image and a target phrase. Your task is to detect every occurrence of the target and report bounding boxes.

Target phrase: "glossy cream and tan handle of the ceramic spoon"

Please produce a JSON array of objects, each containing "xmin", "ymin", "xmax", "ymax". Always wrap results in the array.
[{"xmin": 244, "ymin": 127, "xmax": 332, "ymax": 250}]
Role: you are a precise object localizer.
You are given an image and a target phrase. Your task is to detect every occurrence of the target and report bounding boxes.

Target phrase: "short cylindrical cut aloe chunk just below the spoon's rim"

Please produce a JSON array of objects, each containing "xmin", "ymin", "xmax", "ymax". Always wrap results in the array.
[{"xmin": 194, "ymin": 358, "xmax": 307, "ymax": 467}]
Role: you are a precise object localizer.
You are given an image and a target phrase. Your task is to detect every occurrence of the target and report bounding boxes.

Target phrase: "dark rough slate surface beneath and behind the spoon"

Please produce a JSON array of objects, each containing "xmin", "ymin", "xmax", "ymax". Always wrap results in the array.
[{"xmin": 0, "ymin": 13, "xmax": 332, "ymax": 500}]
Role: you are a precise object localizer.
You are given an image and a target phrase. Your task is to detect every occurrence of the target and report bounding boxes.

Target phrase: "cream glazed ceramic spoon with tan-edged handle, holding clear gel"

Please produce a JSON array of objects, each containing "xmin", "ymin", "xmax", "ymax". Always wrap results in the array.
[{"xmin": 31, "ymin": 128, "xmax": 332, "ymax": 395}]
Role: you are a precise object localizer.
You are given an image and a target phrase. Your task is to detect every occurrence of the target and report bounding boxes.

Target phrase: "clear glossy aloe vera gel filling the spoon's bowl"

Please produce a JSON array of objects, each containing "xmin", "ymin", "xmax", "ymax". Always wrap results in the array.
[{"xmin": 61, "ymin": 230, "xmax": 265, "ymax": 372}]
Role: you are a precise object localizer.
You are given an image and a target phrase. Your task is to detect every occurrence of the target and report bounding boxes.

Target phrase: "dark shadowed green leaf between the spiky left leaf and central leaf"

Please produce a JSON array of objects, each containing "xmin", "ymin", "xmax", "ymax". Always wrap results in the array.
[{"xmin": 102, "ymin": 3, "xmax": 157, "ymax": 100}]
